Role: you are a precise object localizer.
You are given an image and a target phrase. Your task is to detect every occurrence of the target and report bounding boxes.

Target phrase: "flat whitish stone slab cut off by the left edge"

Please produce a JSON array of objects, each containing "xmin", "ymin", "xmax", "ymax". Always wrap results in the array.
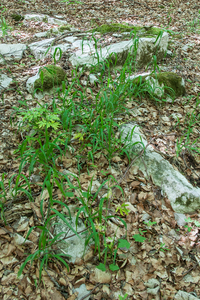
[{"xmin": 0, "ymin": 44, "xmax": 26, "ymax": 64}]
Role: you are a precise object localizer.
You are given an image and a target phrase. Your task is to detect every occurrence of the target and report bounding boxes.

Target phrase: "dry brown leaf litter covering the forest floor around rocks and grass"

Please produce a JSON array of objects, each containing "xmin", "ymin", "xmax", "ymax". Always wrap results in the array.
[{"xmin": 0, "ymin": 0, "xmax": 200, "ymax": 300}]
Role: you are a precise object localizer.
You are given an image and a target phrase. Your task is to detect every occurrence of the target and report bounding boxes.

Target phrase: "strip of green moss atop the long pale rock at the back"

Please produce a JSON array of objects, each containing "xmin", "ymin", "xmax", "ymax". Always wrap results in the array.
[{"xmin": 93, "ymin": 23, "xmax": 142, "ymax": 34}]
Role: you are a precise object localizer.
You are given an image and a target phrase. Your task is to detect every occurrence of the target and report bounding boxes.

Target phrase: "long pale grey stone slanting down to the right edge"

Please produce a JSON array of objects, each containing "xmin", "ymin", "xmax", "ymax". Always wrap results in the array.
[{"xmin": 120, "ymin": 124, "xmax": 200, "ymax": 213}]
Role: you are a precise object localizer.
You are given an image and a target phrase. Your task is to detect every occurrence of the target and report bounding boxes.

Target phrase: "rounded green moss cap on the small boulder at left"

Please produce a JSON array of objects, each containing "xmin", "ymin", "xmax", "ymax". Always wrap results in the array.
[{"xmin": 34, "ymin": 65, "xmax": 66, "ymax": 91}]
